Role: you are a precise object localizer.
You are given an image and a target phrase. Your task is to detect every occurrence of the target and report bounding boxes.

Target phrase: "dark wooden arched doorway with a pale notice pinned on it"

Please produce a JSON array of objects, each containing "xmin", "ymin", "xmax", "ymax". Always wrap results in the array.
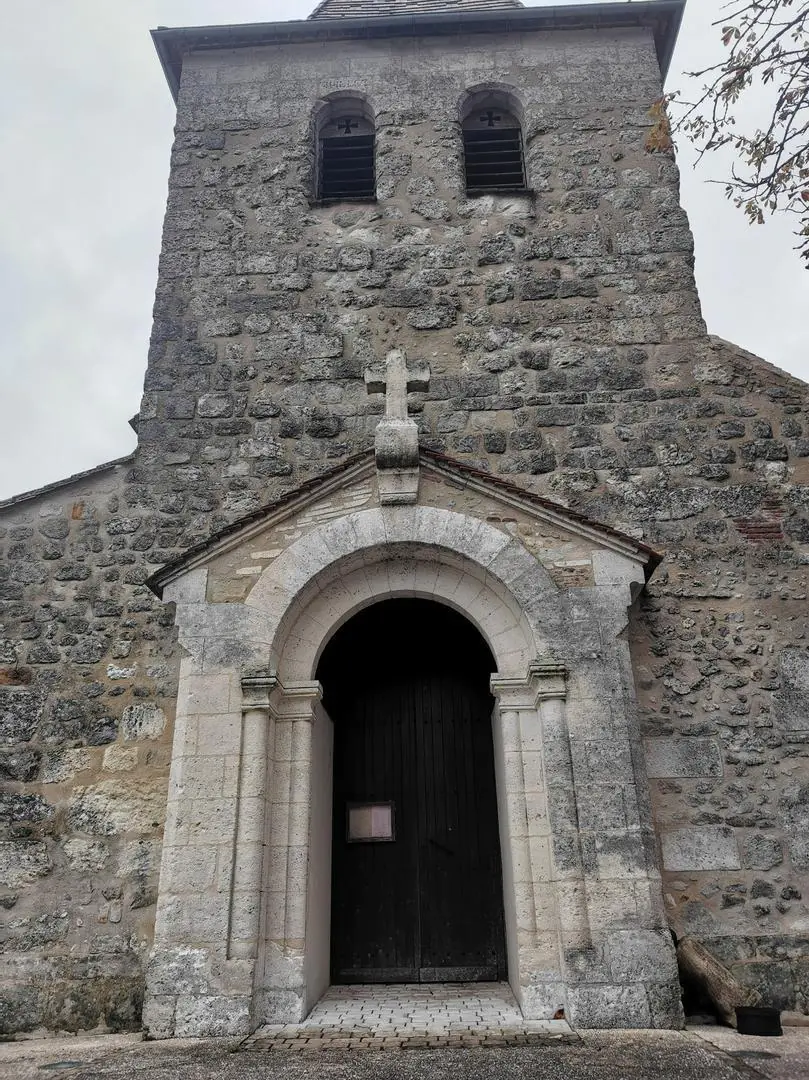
[{"xmin": 318, "ymin": 598, "xmax": 507, "ymax": 983}]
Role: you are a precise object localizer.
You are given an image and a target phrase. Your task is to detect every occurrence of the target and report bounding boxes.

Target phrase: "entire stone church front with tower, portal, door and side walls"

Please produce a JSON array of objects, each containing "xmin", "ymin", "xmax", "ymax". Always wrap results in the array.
[{"xmin": 0, "ymin": 0, "xmax": 809, "ymax": 1038}]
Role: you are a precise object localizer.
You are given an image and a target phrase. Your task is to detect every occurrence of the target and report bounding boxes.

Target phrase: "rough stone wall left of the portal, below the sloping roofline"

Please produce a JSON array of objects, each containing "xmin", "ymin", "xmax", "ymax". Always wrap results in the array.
[{"xmin": 0, "ymin": 462, "xmax": 176, "ymax": 1036}]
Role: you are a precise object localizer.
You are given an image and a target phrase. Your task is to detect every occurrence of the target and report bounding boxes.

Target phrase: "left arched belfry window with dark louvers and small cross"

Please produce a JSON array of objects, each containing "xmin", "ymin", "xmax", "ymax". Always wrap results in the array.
[{"xmin": 318, "ymin": 112, "xmax": 376, "ymax": 200}]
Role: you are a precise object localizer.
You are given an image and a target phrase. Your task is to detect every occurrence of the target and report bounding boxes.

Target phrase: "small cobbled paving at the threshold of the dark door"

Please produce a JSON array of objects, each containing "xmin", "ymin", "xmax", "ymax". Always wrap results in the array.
[{"xmin": 243, "ymin": 983, "xmax": 571, "ymax": 1050}]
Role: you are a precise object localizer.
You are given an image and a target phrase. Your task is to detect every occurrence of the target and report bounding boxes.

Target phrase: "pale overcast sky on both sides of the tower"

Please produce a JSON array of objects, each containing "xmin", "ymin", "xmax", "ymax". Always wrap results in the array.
[{"xmin": 0, "ymin": 0, "xmax": 809, "ymax": 499}]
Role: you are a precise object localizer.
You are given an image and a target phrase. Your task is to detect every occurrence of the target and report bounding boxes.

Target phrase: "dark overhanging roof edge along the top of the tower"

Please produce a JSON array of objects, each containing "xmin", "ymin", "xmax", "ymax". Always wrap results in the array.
[{"xmin": 151, "ymin": 0, "xmax": 686, "ymax": 102}]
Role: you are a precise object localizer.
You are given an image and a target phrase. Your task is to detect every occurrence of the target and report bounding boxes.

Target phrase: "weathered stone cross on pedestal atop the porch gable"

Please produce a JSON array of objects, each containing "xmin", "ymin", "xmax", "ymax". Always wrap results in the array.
[{"xmin": 365, "ymin": 349, "xmax": 430, "ymax": 502}]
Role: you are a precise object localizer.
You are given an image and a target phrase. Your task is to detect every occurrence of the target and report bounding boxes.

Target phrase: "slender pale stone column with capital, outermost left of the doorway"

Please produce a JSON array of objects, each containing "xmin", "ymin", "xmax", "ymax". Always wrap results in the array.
[{"xmin": 228, "ymin": 676, "xmax": 278, "ymax": 959}]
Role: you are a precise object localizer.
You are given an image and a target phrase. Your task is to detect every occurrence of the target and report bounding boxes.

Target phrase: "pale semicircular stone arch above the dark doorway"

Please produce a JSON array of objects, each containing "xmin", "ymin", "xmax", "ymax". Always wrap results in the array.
[{"xmin": 246, "ymin": 507, "xmax": 561, "ymax": 681}]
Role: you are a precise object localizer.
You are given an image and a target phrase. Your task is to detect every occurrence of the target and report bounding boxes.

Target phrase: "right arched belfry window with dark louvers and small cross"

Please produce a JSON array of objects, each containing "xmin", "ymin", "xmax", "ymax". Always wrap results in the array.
[{"xmin": 463, "ymin": 107, "xmax": 526, "ymax": 194}]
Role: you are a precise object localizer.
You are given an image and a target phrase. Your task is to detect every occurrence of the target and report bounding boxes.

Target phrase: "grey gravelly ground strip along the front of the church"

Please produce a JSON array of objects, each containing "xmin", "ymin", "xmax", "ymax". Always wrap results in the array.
[{"xmin": 0, "ymin": 1028, "xmax": 809, "ymax": 1080}]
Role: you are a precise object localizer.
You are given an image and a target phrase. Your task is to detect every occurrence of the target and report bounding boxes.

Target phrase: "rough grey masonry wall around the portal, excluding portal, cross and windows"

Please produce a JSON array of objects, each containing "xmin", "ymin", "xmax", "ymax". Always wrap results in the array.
[{"xmin": 0, "ymin": 19, "xmax": 809, "ymax": 1030}]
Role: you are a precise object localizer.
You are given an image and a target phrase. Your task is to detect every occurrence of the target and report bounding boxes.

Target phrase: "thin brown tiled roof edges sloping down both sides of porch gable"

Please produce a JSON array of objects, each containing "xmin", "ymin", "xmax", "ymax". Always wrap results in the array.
[{"xmin": 146, "ymin": 447, "xmax": 663, "ymax": 598}]
